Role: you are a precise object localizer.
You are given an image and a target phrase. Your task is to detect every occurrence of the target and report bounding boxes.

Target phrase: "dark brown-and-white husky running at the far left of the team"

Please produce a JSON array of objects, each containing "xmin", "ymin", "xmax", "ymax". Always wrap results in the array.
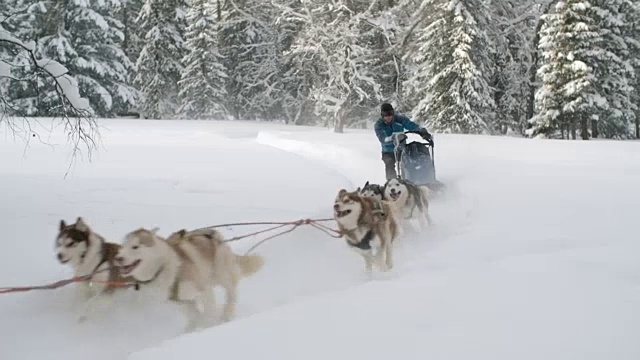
[{"xmin": 55, "ymin": 217, "xmax": 133, "ymax": 322}]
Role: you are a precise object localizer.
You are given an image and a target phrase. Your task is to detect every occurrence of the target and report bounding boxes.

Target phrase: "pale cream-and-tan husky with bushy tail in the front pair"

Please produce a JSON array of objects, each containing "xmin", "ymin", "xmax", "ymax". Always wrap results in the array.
[{"xmin": 116, "ymin": 228, "xmax": 264, "ymax": 332}]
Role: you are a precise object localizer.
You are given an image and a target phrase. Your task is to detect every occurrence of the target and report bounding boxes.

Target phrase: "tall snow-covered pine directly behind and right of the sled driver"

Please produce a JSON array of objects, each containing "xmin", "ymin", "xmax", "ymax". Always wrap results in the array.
[{"xmin": 407, "ymin": 0, "xmax": 495, "ymax": 134}]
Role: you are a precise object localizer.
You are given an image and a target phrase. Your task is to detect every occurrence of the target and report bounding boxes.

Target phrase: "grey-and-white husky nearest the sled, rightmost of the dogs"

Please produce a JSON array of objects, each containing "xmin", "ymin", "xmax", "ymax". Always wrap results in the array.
[{"xmin": 383, "ymin": 177, "xmax": 433, "ymax": 230}]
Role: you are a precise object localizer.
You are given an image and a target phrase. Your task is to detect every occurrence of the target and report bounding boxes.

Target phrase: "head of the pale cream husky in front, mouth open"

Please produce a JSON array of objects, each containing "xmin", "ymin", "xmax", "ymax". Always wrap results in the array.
[{"xmin": 115, "ymin": 228, "xmax": 165, "ymax": 281}]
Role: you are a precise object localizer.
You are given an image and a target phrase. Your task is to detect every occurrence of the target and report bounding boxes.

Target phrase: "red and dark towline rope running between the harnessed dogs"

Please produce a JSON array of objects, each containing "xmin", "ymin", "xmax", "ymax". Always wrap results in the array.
[{"xmin": 0, "ymin": 218, "xmax": 342, "ymax": 294}]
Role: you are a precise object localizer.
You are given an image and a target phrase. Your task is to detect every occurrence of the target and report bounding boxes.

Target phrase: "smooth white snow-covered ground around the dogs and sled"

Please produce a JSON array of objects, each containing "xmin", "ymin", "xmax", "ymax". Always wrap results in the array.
[{"xmin": 0, "ymin": 120, "xmax": 640, "ymax": 360}]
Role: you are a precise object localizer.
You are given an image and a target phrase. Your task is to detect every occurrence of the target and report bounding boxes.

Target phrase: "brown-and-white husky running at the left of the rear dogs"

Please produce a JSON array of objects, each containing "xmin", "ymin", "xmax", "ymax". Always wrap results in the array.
[{"xmin": 333, "ymin": 189, "xmax": 399, "ymax": 274}]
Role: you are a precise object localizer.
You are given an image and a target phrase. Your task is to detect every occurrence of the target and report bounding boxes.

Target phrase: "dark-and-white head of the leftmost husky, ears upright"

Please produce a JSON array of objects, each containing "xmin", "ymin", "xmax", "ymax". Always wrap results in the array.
[{"xmin": 55, "ymin": 217, "xmax": 91, "ymax": 266}]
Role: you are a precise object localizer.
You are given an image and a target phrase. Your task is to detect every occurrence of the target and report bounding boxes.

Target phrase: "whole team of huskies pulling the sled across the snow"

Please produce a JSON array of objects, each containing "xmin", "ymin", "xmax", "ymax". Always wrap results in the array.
[{"xmin": 56, "ymin": 178, "xmax": 431, "ymax": 332}]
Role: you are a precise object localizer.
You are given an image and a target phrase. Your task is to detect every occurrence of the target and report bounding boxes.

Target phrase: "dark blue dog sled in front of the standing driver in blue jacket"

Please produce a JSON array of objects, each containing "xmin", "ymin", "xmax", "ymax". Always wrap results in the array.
[{"xmin": 392, "ymin": 131, "xmax": 445, "ymax": 193}]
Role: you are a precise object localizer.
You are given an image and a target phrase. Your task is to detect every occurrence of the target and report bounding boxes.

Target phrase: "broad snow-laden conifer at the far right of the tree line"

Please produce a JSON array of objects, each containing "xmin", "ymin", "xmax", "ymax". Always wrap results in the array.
[{"xmin": 529, "ymin": 0, "xmax": 629, "ymax": 139}]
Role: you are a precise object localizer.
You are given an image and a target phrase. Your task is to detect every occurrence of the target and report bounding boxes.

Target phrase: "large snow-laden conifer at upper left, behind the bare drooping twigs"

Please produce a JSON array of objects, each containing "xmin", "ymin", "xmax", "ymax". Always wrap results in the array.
[{"xmin": 30, "ymin": 0, "xmax": 135, "ymax": 117}]
